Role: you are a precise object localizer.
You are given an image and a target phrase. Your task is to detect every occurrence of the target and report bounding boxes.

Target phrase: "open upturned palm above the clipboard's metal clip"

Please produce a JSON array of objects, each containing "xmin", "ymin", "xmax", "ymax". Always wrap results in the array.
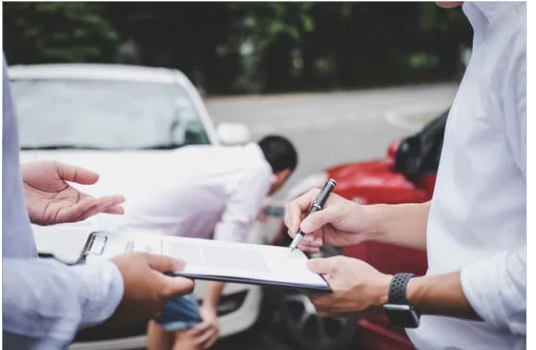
[{"xmin": 21, "ymin": 161, "xmax": 125, "ymax": 225}]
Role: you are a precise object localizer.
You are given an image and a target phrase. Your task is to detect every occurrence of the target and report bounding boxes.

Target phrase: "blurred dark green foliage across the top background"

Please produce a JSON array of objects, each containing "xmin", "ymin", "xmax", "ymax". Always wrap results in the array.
[{"xmin": 3, "ymin": 2, "xmax": 470, "ymax": 94}]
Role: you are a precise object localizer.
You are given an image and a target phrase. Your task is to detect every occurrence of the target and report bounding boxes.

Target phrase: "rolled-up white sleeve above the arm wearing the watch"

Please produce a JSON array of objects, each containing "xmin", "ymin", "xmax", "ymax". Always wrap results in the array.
[{"xmin": 461, "ymin": 245, "xmax": 527, "ymax": 336}]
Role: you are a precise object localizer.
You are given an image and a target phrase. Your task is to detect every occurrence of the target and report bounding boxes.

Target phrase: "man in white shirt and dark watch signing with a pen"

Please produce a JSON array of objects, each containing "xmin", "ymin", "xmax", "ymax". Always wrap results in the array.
[{"xmin": 285, "ymin": 2, "xmax": 527, "ymax": 350}]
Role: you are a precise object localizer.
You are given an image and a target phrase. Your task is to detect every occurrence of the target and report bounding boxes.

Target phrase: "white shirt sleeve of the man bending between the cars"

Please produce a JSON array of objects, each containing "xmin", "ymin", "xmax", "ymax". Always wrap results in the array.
[{"xmin": 214, "ymin": 167, "xmax": 272, "ymax": 242}]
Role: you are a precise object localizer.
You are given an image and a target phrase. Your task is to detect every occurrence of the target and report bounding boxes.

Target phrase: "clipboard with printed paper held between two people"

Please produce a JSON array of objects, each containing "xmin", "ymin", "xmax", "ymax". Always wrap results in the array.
[{"xmin": 34, "ymin": 227, "xmax": 331, "ymax": 292}]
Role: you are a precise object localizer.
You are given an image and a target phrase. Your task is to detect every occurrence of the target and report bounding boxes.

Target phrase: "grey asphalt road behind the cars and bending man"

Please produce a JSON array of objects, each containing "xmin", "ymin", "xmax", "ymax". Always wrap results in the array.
[{"xmin": 207, "ymin": 84, "xmax": 456, "ymax": 350}]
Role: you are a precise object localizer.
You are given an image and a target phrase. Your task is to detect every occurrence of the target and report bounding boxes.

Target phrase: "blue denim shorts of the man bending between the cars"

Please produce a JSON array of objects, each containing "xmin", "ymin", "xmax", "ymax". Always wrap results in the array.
[{"xmin": 155, "ymin": 294, "xmax": 202, "ymax": 332}]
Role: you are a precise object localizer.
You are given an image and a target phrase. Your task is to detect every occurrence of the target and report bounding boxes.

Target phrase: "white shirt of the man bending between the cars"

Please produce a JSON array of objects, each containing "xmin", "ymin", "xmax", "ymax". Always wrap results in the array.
[{"xmin": 115, "ymin": 143, "xmax": 274, "ymax": 241}]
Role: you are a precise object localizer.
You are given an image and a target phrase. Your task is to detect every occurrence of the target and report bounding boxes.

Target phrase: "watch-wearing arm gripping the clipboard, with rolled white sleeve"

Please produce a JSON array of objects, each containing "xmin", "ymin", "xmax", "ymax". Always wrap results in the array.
[{"xmin": 308, "ymin": 246, "xmax": 527, "ymax": 336}]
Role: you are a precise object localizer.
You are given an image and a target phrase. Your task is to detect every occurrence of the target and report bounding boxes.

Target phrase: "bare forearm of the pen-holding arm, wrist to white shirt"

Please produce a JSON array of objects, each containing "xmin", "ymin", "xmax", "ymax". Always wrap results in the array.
[{"xmin": 369, "ymin": 202, "xmax": 430, "ymax": 250}]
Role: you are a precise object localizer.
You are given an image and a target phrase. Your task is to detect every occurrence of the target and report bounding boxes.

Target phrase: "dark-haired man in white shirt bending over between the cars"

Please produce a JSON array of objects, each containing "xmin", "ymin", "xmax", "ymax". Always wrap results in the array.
[{"xmin": 112, "ymin": 136, "xmax": 298, "ymax": 349}]
